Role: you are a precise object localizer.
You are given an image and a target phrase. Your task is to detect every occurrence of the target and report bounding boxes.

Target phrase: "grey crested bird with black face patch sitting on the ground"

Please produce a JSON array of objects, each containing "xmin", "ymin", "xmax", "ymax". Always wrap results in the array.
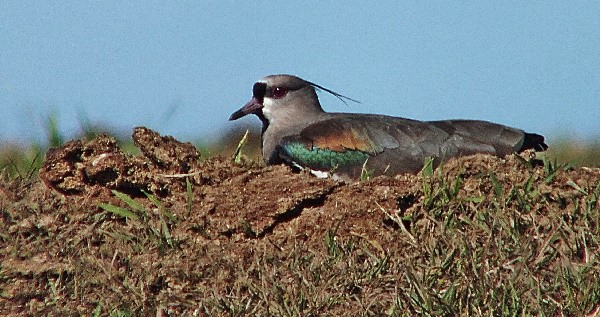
[{"xmin": 229, "ymin": 74, "xmax": 548, "ymax": 181}]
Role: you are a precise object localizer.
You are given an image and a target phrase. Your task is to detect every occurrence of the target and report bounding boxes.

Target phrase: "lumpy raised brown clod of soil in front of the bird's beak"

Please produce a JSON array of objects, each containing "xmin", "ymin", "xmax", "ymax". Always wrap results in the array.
[{"xmin": 40, "ymin": 127, "xmax": 200, "ymax": 196}]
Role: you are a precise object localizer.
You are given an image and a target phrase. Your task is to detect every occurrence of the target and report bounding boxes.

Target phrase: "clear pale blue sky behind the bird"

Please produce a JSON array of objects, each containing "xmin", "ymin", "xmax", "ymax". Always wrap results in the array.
[{"xmin": 0, "ymin": 0, "xmax": 600, "ymax": 143}]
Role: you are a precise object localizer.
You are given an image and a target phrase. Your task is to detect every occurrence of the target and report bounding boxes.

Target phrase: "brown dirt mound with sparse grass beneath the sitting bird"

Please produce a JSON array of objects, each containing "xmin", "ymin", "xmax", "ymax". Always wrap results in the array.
[{"xmin": 0, "ymin": 128, "xmax": 600, "ymax": 316}]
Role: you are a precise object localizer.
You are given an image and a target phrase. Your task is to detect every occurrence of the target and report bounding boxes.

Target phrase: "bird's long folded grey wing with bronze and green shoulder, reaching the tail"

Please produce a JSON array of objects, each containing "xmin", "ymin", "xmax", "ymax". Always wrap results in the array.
[{"xmin": 279, "ymin": 114, "xmax": 545, "ymax": 177}]
